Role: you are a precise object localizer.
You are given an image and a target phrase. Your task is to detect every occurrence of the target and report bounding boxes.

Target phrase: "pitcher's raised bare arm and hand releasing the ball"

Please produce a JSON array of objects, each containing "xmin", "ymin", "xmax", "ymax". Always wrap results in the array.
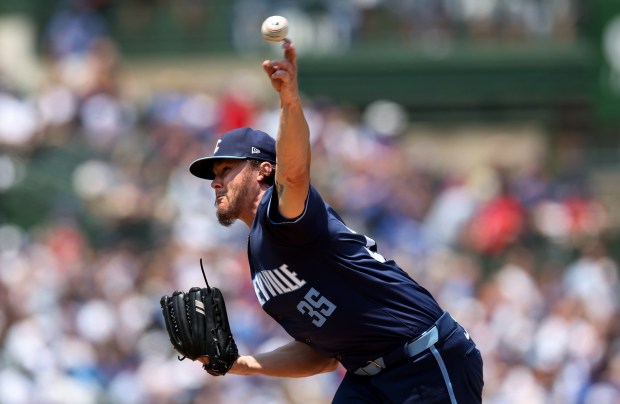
[{"xmin": 263, "ymin": 39, "xmax": 310, "ymax": 219}]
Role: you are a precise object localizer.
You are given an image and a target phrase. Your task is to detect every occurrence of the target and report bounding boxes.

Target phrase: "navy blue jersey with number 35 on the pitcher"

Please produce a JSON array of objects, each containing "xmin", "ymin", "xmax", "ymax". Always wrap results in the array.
[{"xmin": 248, "ymin": 187, "xmax": 443, "ymax": 369}]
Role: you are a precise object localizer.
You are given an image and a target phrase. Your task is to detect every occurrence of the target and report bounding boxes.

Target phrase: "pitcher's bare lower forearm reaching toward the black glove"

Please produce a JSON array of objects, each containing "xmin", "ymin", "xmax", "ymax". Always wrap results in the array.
[{"xmin": 229, "ymin": 341, "xmax": 338, "ymax": 377}]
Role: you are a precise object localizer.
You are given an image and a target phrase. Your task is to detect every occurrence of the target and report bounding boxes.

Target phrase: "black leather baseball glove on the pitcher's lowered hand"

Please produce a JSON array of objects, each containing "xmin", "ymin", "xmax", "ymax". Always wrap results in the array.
[{"xmin": 160, "ymin": 284, "xmax": 239, "ymax": 376}]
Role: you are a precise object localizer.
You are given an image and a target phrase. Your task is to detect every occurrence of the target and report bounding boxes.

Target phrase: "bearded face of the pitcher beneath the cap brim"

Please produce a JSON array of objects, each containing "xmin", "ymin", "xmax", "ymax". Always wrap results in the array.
[{"xmin": 211, "ymin": 160, "xmax": 254, "ymax": 226}]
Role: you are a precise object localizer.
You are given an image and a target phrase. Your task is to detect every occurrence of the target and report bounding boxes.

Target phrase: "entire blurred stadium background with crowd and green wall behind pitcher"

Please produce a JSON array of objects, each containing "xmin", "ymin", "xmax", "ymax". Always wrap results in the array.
[{"xmin": 0, "ymin": 0, "xmax": 620, "ymax": 404}]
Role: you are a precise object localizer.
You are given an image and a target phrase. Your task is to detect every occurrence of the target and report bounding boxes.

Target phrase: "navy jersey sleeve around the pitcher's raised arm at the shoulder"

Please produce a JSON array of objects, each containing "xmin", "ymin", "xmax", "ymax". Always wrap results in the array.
[{"xmin": 265, "ymin": 186, "xmax": 328, "ymax": 245}]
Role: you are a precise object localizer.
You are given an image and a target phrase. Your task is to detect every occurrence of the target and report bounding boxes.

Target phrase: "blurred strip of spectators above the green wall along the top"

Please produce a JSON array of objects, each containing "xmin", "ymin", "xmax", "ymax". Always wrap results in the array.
[{"xmin": 37, "ymin": 0, "xmax": 590, "ymax": 54}]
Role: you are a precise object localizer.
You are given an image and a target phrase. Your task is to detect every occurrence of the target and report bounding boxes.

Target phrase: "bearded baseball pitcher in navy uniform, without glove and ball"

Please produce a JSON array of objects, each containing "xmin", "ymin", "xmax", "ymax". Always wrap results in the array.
[{"xmin": 190, "ymin": 40, "xmax": 483, "ymax": 404}]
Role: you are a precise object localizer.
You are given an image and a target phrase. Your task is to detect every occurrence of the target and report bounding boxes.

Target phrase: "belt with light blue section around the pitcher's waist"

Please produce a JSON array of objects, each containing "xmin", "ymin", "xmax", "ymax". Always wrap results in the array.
[{"xmin": 353, "ymin": 312, "xmax": 456, "ymax": 376}]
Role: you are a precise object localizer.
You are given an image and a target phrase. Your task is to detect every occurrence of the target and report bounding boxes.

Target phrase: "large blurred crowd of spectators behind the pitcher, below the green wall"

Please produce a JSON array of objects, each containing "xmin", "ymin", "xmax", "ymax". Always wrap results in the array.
[{"xmin": 0, "ymin": 2, "xmax": 620, "ymax": 404}]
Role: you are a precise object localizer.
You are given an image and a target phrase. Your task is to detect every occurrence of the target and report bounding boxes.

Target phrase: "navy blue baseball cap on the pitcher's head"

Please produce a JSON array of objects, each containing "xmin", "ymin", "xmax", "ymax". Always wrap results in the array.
[{"xmin": 189, "ymin": 128, "xmax": 276, "ymax": 180}]
